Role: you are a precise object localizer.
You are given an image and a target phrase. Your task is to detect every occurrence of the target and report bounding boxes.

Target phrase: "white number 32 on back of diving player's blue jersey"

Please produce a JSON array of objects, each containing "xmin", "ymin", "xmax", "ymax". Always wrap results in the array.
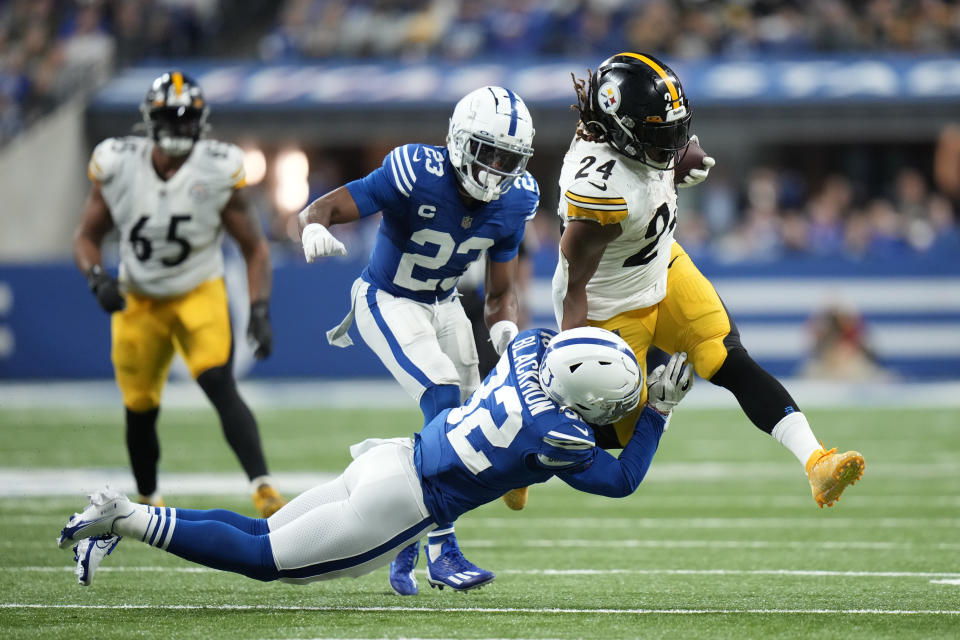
[{"xmin": 447, "ymin": 367, "xmax": 523, "ymax": 473}]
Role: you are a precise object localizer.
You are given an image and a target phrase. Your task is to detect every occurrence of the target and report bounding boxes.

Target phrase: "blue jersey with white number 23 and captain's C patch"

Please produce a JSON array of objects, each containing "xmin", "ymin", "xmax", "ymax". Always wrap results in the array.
[{"xmin": 346, "ymin": 144, "xmax": 540, "ymax": 302}]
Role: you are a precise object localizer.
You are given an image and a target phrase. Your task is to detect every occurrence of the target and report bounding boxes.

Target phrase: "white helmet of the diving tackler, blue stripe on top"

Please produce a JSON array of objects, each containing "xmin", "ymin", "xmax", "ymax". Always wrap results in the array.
[{"xmin": 540, "ymin": 327, "xmax": 643, "ymax": 425}]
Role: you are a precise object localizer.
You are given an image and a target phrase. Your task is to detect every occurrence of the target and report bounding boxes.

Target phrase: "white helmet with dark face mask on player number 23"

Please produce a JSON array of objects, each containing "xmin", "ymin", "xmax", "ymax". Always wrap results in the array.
[{"xmin": 447, "ymin": 87, "xmax": 534, "ymax": 202}]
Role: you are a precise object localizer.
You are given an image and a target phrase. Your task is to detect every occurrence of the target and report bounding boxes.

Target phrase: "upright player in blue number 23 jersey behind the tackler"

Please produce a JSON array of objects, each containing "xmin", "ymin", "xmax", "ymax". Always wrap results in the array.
[{"xmin": 299, "ymin": 87, "xmax": 540, "ymax": 595}]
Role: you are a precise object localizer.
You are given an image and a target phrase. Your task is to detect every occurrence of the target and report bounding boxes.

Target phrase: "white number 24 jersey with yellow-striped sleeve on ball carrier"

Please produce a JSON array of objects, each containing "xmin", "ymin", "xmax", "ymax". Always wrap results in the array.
[{"xmin": 554, "ymin": 139, "xmax": 677, "ymax": 320}]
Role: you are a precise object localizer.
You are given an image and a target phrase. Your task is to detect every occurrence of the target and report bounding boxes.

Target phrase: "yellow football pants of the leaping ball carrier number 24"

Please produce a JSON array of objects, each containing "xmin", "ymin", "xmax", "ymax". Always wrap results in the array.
[{"xmin": 590, "ymin": 242, "xmax": 733, "ymax": 445}]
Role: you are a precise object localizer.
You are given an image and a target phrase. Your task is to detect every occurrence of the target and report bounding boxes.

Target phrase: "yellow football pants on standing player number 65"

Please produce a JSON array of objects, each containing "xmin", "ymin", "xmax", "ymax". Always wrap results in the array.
[{"xmin": 111, "ymin": 278, "xmax": 233, "ymax": 412}]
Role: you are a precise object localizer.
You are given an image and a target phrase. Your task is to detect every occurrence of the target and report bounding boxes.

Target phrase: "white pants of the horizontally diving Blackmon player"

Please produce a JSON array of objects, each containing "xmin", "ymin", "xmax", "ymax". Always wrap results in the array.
[{"xmin": 267, "ymin": 438, "xmax": 437, "ymax": 583}]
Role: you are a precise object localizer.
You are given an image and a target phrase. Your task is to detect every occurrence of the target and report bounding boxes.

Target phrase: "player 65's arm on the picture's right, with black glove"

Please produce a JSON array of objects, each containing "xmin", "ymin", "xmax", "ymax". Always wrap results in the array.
[{"xmin": 220, "ymin": 190, "xmax": 273, "ymax": 360}]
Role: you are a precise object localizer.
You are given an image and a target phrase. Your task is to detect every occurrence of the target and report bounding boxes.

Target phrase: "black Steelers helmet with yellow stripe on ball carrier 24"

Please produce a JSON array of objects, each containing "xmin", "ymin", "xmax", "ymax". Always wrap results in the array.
[{"xmin": 581, "ymin": 53, "xmax": 693, "ymax": 169}]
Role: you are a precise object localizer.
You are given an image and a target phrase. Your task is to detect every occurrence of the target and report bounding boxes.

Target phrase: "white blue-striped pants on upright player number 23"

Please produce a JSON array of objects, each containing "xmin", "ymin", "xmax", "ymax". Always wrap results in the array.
[{"xmin": 351, "ymin": 278, "xmax": 480, "ymax": 402}]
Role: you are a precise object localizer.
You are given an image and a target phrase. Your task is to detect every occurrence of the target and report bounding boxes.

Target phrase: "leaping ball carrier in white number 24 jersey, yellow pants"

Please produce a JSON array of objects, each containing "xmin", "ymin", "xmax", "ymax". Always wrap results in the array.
[{"xmin": 553, "ymin": 53, "xmax": 864, "ymax": 507}]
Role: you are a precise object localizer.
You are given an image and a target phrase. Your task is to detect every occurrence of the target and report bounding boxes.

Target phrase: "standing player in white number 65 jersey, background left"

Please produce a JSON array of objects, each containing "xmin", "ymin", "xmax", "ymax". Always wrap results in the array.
[{"xmin": 74, "ymin": 71, "xmax": 285, "ymax": 517}]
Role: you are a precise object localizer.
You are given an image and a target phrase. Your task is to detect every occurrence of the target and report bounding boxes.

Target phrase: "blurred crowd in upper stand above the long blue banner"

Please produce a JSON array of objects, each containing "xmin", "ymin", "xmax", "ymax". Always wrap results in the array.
[{"xmin": 261, "ymin": 0, "xmax": 960, "ymax": 59}]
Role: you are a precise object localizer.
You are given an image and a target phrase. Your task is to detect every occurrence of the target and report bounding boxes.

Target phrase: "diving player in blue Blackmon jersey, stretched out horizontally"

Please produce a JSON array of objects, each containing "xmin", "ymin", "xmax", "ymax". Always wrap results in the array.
[{"xmin": 59, "ymin": 327, "xmax": 692, "ymax": 583}]
